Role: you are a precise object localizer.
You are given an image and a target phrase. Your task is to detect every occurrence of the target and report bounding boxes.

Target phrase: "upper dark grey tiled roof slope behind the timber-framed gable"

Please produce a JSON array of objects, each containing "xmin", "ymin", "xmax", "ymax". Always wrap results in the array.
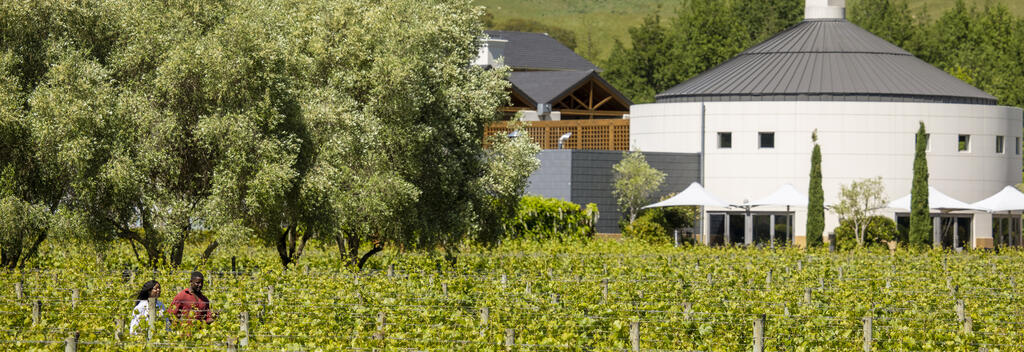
[{"xmin": 484, "ymin": 31, "xmax": 599, "ymax": 71}]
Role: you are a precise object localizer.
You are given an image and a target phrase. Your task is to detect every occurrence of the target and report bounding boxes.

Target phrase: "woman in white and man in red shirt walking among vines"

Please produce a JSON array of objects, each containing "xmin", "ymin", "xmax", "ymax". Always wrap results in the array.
[{"xmin": 129, "ymin": 271, "xmax": 217, "ymax": 335}]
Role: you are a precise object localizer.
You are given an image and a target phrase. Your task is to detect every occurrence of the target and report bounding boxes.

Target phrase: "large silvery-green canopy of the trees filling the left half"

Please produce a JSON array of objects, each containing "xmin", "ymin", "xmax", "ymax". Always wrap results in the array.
[{"xmin": 0, "ymin": 0, "xmax": 535, "ymax": 266}]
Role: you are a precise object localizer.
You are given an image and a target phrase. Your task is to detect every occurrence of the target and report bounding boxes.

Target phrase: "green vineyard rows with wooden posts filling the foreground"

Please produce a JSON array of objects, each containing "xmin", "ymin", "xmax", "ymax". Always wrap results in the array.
[{"xmin": 0, "ymin": 240, "xmax": 1024, "ymax": 351}]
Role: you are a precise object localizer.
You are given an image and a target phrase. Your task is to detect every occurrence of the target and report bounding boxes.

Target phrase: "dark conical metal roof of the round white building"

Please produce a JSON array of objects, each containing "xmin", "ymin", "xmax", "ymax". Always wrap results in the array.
[{"xmin": 655, "ymin": 19, "xmax": 996, "ymax": 104}]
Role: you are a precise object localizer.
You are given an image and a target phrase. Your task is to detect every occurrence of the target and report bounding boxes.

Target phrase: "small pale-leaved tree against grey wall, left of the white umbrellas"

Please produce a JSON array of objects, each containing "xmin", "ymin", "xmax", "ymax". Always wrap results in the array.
[{"xmin": 611, "ymin": 151, "xmax": 666, "ymax": 223}]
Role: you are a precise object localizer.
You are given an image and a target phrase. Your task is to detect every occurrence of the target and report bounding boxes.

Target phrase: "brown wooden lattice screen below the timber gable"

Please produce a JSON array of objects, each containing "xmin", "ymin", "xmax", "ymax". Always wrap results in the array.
[{"xmin": 483, "ymin": 119, "xmax": 630, "ymax": 150}]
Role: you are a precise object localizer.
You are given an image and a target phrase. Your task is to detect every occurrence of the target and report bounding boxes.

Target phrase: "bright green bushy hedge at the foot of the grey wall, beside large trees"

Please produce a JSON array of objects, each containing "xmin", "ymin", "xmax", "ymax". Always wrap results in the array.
[{"xmin": 506, "ymin": 195, "xmax": 598, "ymax": 241}]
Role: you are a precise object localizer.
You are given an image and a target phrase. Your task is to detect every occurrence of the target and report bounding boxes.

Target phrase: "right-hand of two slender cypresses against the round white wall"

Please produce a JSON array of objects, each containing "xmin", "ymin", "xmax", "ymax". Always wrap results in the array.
[{"xmin": 909, "ymin": 122, "xmax": 932, "ymax": 246}]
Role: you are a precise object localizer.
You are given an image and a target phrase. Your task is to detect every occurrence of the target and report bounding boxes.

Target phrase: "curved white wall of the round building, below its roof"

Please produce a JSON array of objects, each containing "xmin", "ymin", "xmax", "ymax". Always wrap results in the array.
[{"xmin": 630, "ymin": 101, "xmax": 1022, "ymax": 246}]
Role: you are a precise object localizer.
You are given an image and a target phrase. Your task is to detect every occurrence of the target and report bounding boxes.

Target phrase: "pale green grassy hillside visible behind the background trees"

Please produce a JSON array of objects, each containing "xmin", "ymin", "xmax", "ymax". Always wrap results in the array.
[{"xmin": 475, "ymin": 0, "xmax": 1024, "ymax": 63}]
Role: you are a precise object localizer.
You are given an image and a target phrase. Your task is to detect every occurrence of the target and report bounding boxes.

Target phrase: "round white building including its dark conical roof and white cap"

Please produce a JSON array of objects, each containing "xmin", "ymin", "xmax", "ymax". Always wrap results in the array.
[{"xmin": 630, "ymin": 0, "xmax": 1022, "ymax": 248}]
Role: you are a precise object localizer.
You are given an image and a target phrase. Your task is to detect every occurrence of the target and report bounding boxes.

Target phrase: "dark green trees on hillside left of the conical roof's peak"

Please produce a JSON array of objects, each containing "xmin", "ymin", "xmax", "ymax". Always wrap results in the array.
[{"xmin": 602, "ymin": 0, "xmax": 803, "ymax": 102}]
